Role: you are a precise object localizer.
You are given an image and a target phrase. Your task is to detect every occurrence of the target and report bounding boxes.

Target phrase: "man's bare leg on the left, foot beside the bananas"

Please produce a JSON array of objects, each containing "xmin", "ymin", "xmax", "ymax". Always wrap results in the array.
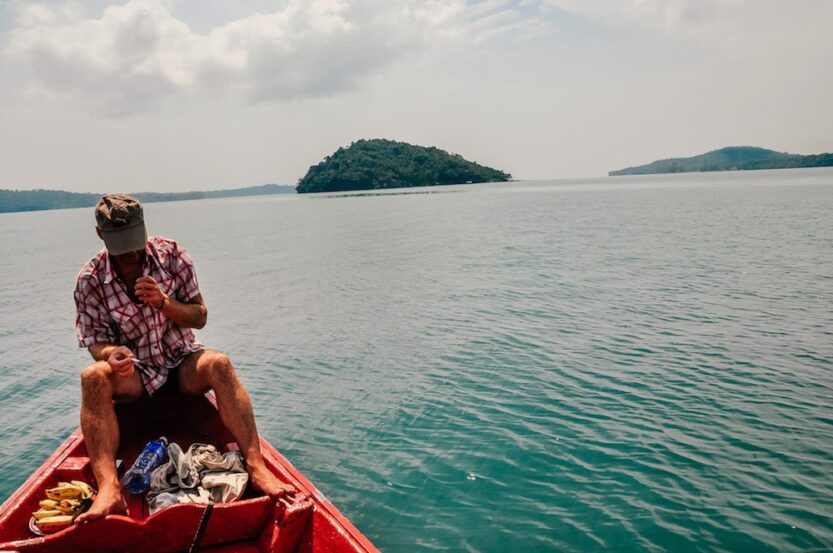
[{"xmin": 75, "ymin": 361, "xmax": 142, "ymax": 523}]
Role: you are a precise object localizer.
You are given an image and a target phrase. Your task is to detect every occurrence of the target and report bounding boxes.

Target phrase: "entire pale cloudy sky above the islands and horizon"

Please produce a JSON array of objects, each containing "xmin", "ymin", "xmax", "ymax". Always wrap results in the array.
[{"xmin": 0, "ymin": 0, "xmax": 833, "ymax": 192}]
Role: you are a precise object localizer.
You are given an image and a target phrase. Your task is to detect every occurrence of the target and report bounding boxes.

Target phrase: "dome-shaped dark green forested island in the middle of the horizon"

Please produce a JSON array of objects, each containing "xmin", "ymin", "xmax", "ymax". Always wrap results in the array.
[{"xmin": 296, "ymin": 139, "xmax": 512, "ymax": 194}]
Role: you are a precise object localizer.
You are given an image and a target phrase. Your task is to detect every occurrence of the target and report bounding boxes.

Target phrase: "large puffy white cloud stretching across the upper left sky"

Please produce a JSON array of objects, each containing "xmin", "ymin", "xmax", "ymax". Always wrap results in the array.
[{"xmin": 5, "ymin": 0, "xmax": 536, "ymax": 116}]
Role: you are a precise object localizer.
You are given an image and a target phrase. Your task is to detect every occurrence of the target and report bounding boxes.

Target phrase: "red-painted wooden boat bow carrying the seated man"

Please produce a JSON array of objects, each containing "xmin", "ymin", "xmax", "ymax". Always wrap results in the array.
[{"xmin": 0, "ymin": 393, "xmax": 378, "ymax": 553}]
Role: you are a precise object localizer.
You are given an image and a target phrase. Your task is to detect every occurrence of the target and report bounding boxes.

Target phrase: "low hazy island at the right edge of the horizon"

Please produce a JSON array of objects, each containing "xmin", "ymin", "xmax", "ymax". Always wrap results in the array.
[{"xmin": 608, "ymin": 146, "xmax": 833, "ymax": 177}]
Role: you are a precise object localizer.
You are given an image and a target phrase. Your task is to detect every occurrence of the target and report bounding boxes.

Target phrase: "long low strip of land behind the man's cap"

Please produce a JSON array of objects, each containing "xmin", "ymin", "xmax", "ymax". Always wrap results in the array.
[{"xmin": 0, "ymin": 184, "xmax": 295, "ymax": 213}]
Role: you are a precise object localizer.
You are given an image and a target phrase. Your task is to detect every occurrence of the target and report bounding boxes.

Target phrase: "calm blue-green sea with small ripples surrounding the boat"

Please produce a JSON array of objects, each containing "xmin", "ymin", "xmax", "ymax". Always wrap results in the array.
[{"xmin": 0, "ymin": 170, "xmax": 833, "ymax": 553}]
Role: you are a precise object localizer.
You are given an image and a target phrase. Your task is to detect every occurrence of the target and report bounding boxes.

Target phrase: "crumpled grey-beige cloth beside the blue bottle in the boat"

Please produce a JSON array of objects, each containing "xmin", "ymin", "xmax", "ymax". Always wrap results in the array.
[{"xmin": 147, "ymin": 443, "xmax": 249, "ymax": 514}]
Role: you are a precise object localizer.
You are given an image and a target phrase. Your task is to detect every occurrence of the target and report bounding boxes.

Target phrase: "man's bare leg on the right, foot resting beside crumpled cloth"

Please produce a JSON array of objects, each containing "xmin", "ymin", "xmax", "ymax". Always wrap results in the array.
[{"xmin": 179, "ymin": 350, "xmax": 295, "ymax": 498}]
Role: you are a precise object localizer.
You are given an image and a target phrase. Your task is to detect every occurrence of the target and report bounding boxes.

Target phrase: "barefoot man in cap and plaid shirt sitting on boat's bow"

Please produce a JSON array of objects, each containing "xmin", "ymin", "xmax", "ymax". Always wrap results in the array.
[{"xmin": 75, "ymin": 194, "xmax": 294, "ymax": 522}]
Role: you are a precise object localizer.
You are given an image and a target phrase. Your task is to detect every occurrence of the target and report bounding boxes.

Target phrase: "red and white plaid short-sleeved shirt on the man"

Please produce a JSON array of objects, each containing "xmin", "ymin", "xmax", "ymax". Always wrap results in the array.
[{"xmin": 75, "ymin": 236, "xmax": 205, "ymax": 395}]
